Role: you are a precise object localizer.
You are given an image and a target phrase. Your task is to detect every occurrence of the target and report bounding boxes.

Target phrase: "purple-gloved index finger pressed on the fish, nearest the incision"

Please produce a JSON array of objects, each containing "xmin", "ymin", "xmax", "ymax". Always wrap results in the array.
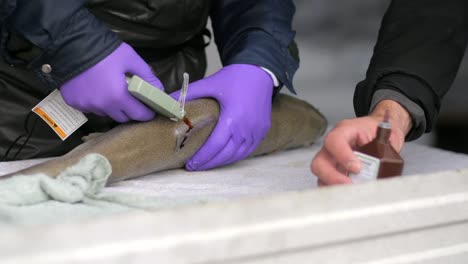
[{"xmin": 186, "ymin": 118, "xmax": 231, "ymax": 170}]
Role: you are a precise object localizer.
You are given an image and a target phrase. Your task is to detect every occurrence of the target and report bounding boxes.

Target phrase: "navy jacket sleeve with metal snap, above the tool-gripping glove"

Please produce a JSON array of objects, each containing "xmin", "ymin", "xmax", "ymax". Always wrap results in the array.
[{"xmin": 0, "ymin": 0, "xmax": 121, "ymax": 89}]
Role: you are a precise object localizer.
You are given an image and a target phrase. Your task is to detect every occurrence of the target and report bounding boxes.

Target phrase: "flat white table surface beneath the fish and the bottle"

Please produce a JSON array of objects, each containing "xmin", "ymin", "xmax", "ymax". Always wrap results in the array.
[{"xmin": 0, "ymin": 143, "xmax": 468, "ymax": 202}]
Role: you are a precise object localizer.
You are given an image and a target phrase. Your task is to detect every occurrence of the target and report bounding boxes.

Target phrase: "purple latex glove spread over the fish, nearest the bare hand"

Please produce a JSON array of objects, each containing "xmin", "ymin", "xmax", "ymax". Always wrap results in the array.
[{"xmin": 172, "ymin": 64, "xmax": 273, "ymax": 171}]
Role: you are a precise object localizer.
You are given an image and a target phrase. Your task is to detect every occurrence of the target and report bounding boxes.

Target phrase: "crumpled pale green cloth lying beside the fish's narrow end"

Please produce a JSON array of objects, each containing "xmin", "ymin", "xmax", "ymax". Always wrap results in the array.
[{"xmin": 0, "ymin": 154, "xmax": 182, "ymax": 225}]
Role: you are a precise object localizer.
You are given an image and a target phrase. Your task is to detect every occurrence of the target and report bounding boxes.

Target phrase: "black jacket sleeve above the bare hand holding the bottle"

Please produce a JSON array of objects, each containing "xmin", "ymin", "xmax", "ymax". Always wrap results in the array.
[{"xmin": 354, "ymin": 0, "xmax": 468, "ymax": 140}]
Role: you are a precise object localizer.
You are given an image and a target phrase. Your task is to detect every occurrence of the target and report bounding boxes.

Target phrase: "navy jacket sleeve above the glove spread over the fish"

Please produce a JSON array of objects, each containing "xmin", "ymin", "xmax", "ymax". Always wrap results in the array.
[{"xmin": 211, "ymin": 0, "xmax": 299, "ymax": 93}]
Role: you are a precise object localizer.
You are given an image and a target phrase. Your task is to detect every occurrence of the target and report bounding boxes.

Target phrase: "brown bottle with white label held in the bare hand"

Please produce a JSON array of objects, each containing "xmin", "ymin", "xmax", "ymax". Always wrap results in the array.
[{"xmin": 350, "ymin": 112, "xmax": 404, "ymax": 184}]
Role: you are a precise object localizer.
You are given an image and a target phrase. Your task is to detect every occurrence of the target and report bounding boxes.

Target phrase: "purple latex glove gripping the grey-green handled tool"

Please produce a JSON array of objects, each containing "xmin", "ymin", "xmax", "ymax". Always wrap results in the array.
[{"xmin": 60, "ymin": 43, "xmax": 164, "ymax": 122}]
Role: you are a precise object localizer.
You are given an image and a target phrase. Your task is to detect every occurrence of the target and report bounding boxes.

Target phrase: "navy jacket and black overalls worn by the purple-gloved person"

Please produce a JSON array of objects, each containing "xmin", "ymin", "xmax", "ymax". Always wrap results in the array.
[{"xmin": 0, "ymin": 0, "xmax": 298, "ymax": 160}]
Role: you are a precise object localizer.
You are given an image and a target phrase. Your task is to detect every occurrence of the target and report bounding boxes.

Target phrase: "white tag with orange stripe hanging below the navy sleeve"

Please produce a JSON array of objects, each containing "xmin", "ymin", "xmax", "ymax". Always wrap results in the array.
[{"xmin": 32, "ymin": 90, "xmax": 88, "ymax": 140}]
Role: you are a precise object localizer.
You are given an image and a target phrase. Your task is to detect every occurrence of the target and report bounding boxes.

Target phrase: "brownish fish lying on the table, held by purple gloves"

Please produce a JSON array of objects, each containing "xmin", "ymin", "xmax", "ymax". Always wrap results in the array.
[{"xmin": 0, "ymin": 94, "xmax": 327, "ymax": 184}]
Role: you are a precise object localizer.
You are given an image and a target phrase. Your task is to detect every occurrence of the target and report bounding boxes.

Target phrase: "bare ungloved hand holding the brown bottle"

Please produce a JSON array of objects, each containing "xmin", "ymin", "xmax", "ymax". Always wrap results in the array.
[{"xmin": 311, "ymin": 100, "xmax": 411, "ymax": 185}]
